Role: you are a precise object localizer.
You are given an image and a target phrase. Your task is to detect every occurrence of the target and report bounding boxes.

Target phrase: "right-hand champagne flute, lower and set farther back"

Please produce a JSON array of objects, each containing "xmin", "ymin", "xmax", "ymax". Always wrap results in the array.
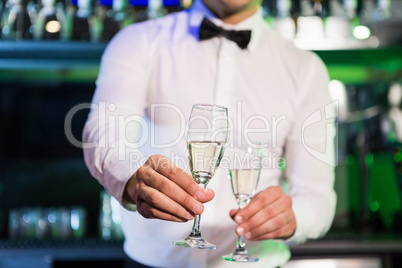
[{"xmin": 222, "ymin": 144, "xmax": 262, "ymax": 262}]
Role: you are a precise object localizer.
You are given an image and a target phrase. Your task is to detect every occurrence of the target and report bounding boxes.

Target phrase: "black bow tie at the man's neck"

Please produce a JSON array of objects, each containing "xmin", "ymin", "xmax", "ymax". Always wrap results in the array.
[{"xmin": 200, "ymin": 18, "xmax": 251, "ymax": 49}]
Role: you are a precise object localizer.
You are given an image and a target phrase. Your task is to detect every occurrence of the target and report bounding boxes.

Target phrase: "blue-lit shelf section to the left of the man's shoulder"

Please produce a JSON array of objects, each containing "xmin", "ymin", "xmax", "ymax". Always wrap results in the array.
[{"xmin": 0, "ymin": 41, "xmax": 106, "ymax": 83}]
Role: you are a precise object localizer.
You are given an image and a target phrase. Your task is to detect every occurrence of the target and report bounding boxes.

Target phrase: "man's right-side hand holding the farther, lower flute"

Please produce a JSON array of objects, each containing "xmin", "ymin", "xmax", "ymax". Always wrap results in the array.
[{"xmin": 230, "ymin": 186, "xmax": 296, "ymax": 240}]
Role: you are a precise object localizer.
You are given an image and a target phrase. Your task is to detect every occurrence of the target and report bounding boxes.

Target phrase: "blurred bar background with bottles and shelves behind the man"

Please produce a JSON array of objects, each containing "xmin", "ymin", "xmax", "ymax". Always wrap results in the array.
[{"xmin": 0, "ymin": 0, "xmax": 402, "ymax": 268}]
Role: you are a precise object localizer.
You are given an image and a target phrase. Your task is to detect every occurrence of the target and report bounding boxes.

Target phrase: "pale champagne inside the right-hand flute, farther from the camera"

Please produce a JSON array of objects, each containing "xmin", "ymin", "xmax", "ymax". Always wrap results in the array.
[{"xmin": 229, "ymin": 169, "xmax": 260, "ymax": 203}]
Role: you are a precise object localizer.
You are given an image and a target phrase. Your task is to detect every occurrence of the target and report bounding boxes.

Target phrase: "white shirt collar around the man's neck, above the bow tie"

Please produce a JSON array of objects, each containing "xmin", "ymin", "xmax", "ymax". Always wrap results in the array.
[{"xmin": 189, "ymin": 0, "xmax": 264, "ymax": 52}]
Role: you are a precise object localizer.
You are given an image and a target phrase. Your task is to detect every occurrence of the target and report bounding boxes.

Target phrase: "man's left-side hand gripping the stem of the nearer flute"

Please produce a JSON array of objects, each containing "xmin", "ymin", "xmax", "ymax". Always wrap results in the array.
[{"xmin": 124, "ymin": 155, "xmax": 215, "ymax": 222}]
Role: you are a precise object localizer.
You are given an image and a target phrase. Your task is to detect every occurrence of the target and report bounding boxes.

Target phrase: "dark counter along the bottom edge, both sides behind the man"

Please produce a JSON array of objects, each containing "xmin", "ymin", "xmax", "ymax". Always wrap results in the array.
[{"xmin": 0, "ymin": 233, "xmax": 402, "ymax": 268}]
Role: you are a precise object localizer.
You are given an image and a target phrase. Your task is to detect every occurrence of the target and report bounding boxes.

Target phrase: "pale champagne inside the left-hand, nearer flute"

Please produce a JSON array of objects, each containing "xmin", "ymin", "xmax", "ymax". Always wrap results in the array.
[{"xmin": 188, "ymin": 141, "xmax": 225, "ymax": 186}]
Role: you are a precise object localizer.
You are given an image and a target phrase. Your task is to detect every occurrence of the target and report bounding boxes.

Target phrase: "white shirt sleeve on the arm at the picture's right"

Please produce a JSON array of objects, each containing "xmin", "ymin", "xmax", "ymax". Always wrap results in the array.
[{"xmin": 285, "ymin": 53, "xmax": 336, "ymax": 244}]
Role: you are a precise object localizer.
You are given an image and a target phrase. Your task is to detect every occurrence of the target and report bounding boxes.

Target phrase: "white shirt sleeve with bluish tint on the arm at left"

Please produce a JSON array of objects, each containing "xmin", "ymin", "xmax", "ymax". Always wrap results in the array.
[{"xmin": 83, "ymin": 25, "xmax": 152, "ymax": 208}]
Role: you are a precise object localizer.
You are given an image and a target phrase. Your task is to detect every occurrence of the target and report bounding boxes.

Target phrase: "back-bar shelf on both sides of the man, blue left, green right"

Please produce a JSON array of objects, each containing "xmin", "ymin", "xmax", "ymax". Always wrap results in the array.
[{"xmin": 0, "ymin": 41, "xmax": 402, "ymax": 84}]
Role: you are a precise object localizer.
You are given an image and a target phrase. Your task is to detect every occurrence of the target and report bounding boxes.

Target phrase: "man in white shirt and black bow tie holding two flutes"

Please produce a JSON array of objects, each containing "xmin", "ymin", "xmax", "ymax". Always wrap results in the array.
[{"xmin": 83, "ymin": 0, "xmax": 336, "ymax": 267}]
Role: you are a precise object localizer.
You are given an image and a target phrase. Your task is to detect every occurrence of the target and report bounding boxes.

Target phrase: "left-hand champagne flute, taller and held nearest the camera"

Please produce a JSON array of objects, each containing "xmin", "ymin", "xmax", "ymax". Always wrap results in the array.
[{"xmin": 173, "ymin": 104, "xmax": 229, "ymax": 249}]
